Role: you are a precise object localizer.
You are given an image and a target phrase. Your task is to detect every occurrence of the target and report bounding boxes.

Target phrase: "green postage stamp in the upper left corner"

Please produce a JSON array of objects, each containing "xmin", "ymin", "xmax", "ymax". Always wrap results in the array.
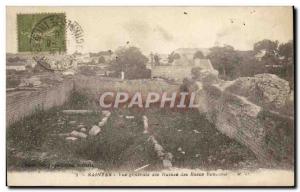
[{"xmin": 17, "ymin": 13, "xmax": 66, "ymax": 52}]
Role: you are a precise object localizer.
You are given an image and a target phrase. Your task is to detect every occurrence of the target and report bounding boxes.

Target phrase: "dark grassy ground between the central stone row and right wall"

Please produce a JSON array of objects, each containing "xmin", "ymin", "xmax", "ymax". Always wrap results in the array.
[{"xmin": 147, "ymin": 109, "xmax": 258, "ymax": 169}]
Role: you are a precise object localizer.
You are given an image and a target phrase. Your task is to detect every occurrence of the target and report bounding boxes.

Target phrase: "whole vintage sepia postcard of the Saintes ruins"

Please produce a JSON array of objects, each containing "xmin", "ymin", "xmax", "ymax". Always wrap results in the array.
[{"xmin": 6, "ymin": 6, "xmax": 295, "ymax": 187}]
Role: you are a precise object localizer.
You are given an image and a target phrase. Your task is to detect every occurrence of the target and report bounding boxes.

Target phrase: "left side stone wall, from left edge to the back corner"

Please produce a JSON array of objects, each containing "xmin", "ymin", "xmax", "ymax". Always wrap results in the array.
[{"xmin": 6, "ymin": 79, "xmax": 73, "ymax": 127}]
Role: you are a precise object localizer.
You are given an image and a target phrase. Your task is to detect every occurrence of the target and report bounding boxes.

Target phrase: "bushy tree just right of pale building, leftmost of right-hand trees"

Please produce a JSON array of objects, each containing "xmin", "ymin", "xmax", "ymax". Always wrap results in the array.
[{"xmin": 207, "ymin": 45, "xmax": 241, "ymax": 80}]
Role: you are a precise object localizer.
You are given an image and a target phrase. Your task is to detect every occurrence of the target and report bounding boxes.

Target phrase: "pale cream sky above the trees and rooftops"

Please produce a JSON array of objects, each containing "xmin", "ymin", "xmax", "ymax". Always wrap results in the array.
[{"xmin": 6, "ymin": 7, "xmax": 293, "ymax": 54}]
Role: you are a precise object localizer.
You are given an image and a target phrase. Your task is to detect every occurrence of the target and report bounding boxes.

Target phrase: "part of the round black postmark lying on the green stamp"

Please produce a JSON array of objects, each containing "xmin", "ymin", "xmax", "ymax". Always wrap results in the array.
[{"xmin": 29, "ymin": 14, "xmax": 66, "ymax": 53}]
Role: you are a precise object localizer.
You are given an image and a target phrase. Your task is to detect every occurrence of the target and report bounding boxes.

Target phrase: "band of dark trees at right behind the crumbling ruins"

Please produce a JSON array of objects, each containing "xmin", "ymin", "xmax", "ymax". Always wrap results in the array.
[{"xmin": 207, "ymin": 39, "xmax": 294, "ymax": 89}]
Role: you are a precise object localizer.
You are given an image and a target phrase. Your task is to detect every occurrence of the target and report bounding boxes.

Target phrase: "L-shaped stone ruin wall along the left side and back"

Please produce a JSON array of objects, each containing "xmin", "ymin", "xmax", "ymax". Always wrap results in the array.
[{"xmin": 6, "ymin": 75, "xmax": 178, "ymax": 127}]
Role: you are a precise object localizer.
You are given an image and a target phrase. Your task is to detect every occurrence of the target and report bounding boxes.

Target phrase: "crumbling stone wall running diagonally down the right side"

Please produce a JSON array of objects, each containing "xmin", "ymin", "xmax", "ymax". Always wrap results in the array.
[{"xmin": 198, "ymin": 76, "xmax": 294, "ymax": 165}]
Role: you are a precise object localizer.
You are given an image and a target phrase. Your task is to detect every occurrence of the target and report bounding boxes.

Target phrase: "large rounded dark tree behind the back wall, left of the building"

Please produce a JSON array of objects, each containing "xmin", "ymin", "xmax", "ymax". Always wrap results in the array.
[{"xmin": 111, "ymin": 47, "xmax": 151, "ymax": 79}]
